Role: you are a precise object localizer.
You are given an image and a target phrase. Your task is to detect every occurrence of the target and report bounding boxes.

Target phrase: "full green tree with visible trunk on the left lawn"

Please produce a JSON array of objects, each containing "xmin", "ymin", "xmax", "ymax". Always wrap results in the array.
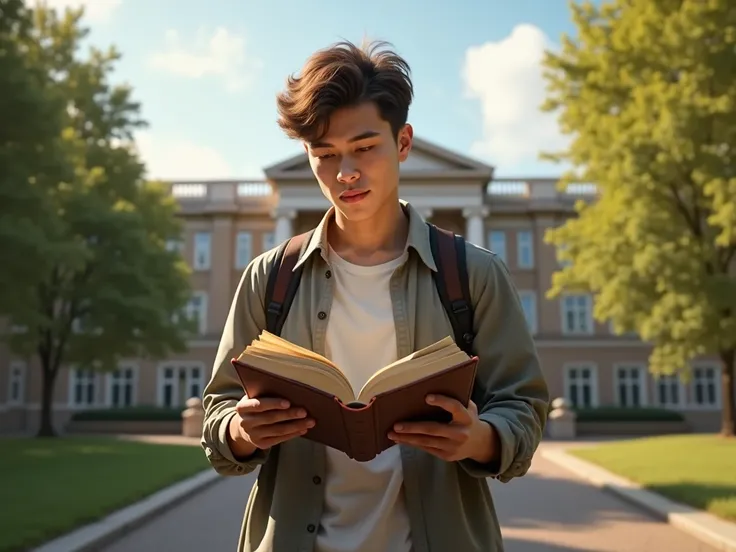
[{"xmin": 4, "ymin": 3, "xmax": 190, "ymax": 436}]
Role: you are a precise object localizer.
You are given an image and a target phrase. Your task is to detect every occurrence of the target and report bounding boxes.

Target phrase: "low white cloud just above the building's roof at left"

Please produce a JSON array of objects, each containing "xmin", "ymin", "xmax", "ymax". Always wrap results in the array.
[{"xmin": 135, "ymin": 131, "xmax": 236, "ymax": 180}]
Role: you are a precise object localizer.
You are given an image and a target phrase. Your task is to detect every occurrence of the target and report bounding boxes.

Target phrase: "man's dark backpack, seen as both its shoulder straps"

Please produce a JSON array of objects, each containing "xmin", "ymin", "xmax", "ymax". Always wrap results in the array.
[{"xmin": 264, "ymin": 222, "xmax": 475, "ymax": 355}]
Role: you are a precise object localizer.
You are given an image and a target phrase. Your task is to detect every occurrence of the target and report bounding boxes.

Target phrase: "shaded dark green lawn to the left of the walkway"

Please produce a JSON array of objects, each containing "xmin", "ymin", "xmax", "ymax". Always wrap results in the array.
[{"xmin": 0, "ymin": 437, "xmax": 208, "ymax": 551}]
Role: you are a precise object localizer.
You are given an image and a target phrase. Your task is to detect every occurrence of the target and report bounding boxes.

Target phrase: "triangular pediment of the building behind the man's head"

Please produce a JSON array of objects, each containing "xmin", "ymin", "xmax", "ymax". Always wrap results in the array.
[{"xmin": 264, "ymin": 137, "xmax": 493, "ymax": 182}]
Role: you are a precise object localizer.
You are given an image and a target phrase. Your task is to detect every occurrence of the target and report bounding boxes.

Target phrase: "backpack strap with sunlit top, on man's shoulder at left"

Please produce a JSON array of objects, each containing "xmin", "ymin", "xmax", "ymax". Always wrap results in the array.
[{"xmin": 264, "ymin": 230, "xmax": 314, "ymax": 335}]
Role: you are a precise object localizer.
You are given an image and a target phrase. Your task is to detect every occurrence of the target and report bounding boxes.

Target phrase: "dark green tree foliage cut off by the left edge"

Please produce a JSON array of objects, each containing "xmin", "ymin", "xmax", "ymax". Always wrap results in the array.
[{"xmin": 0, "ymin": 0, "xmax": 62, "ymax": 312}]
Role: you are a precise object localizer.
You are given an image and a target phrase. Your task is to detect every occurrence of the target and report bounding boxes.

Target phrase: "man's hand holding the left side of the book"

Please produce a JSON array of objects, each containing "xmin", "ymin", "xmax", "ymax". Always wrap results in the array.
[{"xmin": 228, "ymin": 396, "xmax": 314, "ymax": 458}]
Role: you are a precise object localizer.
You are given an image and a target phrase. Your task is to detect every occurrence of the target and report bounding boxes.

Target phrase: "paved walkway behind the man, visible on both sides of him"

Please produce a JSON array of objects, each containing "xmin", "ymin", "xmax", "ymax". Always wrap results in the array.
[{"xmin": 102, "ymin": 443, "xmax": 716, "ymax": 552}]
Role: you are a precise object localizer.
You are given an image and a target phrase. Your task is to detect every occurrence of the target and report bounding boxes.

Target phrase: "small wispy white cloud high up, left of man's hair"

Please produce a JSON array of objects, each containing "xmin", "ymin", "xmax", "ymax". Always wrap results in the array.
[{"xmin": 150, "ymin": 27, "xmax": 262, "ymax": 92}]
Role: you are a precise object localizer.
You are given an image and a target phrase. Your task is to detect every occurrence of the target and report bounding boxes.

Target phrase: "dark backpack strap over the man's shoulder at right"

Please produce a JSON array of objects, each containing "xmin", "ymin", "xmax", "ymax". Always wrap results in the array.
[{"xmin": 427, "ymin": 222, "xmax": 475, "ymax": 355}]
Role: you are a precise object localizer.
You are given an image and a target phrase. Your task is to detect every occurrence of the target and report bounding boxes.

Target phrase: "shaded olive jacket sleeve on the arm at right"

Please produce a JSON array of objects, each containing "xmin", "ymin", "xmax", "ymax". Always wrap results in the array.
[{"xmin": 460, "ymin": 245, "xmax": 549, "ymax": 483}]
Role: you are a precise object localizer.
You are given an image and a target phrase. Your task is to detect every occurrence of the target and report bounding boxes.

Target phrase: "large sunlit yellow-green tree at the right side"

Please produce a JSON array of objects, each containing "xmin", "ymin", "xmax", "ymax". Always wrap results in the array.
[{"xmin": 543, "ymin": 0, "xmax": 736, "ymax": 436}]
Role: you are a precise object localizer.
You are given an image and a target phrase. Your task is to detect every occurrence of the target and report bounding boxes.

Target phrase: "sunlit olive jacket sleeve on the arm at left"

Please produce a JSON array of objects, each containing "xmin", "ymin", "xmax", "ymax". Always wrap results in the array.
[{"xmin": 201, "ymin": 253, "xmax": 270, "ymax": 475}]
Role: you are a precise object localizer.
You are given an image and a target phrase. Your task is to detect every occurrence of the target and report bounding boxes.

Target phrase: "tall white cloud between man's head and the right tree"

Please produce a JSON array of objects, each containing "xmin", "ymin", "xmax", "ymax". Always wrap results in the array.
[{"xmin": 462, "ymin": 24, "xmax": 567, "ymax": 166}]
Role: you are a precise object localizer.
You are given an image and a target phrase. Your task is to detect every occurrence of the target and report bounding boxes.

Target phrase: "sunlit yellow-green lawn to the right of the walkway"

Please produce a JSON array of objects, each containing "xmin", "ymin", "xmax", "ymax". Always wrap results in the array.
[{"xmin": 568, "ymin": 435, "xmax": 736, "ymax": 521}]
